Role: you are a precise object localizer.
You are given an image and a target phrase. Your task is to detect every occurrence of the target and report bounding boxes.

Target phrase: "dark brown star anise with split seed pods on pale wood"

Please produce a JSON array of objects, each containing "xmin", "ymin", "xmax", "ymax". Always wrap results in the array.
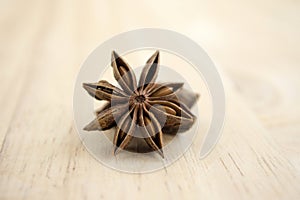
[{"xmin": 83, "ymin": 51, "xmax": 198, "ymax": 157}]
